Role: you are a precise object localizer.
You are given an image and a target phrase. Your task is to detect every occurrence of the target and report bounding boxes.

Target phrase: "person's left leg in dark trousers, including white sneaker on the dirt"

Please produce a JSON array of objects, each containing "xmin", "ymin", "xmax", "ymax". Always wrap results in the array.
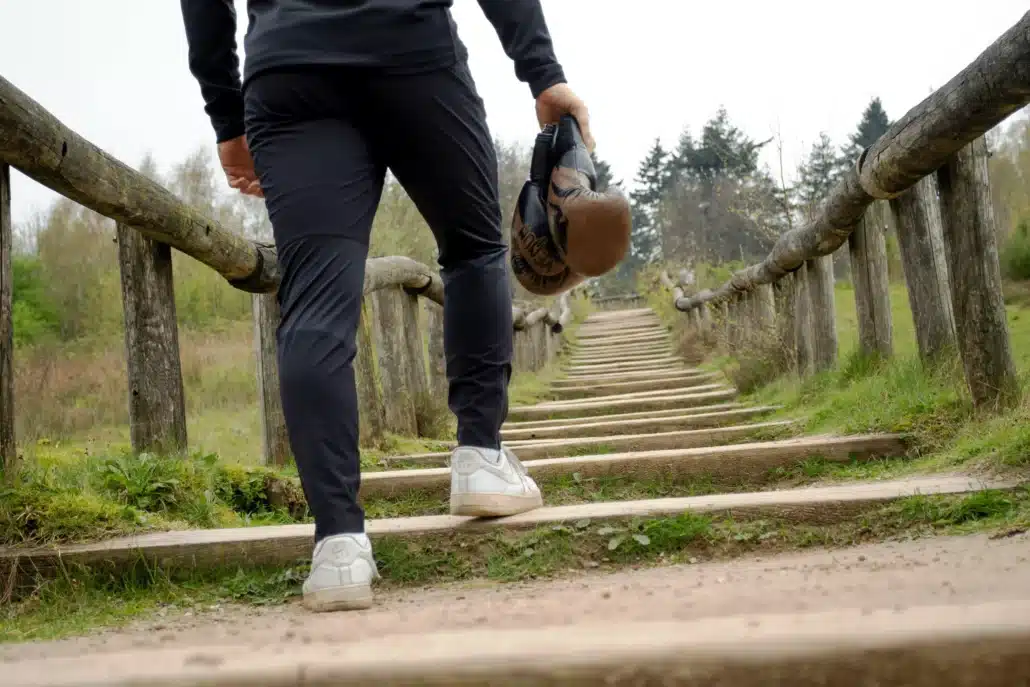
[{"xmin": 247, "ymin": 66, "xmax": 385, "ymax": 610}]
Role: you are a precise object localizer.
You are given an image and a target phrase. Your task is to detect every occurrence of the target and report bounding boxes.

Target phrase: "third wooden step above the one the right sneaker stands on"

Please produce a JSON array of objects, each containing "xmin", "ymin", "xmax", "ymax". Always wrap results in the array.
[{"xmin": 501, "ymin": 406, "xmax": 780, "ymax": 441}]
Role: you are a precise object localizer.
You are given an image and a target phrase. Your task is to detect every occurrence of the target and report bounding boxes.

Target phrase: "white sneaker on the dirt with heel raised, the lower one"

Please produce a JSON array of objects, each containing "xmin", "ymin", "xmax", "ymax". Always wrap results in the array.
[{"xmin": 304, "ymin": 534, "xmax": 379, "ymax": 613}]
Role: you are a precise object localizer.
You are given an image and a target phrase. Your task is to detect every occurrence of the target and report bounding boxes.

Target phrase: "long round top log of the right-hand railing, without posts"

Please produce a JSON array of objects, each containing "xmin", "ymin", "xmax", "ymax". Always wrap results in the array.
[{"xmin": 676, "ymin": 12, "xmax": 1030, "ymax": 311}]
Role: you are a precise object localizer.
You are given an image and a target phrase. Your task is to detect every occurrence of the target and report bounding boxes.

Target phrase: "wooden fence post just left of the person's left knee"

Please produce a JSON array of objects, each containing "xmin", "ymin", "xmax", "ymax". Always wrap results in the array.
[{"xmin": 251, "ymin": 293, "xmax": 290, "ymax": 466}]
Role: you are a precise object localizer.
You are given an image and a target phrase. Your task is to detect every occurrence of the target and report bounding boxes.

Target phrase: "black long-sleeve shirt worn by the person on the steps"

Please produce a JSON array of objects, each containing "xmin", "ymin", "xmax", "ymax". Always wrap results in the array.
[{"xmin": 180, "ymin": 0, "xmax": 564, "ymax": 142}]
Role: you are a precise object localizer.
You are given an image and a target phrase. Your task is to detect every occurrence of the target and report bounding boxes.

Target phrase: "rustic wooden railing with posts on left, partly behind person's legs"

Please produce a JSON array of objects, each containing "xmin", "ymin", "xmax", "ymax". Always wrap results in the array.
[{"xmin": 0, "ymin": 77, "xmax": 572, "ymax": 475}]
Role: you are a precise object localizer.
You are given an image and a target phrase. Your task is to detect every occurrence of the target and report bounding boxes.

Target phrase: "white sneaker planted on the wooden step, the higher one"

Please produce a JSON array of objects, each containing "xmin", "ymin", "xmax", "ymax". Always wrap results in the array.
[{"xmin": 450, "ymin": 446, "xmax": 544, "ymax": 517}]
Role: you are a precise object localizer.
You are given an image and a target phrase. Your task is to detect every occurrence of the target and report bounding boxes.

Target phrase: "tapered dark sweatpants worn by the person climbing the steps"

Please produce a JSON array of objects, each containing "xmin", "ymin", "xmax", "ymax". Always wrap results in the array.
[{"xmin": 245, "ymin": 61, "xmax": 512, "ymax": 541}]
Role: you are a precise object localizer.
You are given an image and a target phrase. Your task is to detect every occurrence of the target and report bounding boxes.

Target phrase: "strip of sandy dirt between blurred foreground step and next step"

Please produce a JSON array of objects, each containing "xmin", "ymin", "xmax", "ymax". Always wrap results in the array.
[{"xmin": 0, "ymin": 534, "xmax": 1030, "ymax": 662}]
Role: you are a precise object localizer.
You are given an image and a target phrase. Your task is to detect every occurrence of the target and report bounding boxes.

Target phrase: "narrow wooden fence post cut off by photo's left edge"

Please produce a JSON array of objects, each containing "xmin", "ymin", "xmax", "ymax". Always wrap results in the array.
[{"xmin": 0, "ymin": 163, "xmax": 18, "ymax": 481}]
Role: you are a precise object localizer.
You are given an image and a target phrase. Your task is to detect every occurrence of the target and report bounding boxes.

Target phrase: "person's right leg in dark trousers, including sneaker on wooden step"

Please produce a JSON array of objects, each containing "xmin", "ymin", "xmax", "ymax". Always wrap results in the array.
[{"xmin": 370, "ymin": 62, "xmax": 543, "ymax": 516}]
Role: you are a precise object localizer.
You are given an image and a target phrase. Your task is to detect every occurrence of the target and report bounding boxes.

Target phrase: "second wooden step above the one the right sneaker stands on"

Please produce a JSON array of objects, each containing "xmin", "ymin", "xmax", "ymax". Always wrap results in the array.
[{"xmin": 381, "ymin": 420, "xmax": 795, "ymax": 466}]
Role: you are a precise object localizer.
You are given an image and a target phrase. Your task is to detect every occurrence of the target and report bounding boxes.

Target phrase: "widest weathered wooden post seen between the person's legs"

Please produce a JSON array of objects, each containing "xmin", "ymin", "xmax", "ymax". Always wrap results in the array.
[{"xmin": 371, "ymin": 286, "xmax": 418, "ymax": 437}]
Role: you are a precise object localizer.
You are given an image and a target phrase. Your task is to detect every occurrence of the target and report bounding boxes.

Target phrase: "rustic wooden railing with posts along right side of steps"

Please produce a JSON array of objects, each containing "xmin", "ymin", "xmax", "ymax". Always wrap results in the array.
[{"xmin": 662, "ymin": 12, "xmax": 1030, "ymax": 414}]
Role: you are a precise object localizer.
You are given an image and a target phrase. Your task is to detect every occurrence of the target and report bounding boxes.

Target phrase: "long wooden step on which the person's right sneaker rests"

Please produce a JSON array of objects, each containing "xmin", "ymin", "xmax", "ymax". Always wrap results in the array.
[{"xmin": 6, "ymin": 476, "xmax": 1016, "ymax": 585}]
